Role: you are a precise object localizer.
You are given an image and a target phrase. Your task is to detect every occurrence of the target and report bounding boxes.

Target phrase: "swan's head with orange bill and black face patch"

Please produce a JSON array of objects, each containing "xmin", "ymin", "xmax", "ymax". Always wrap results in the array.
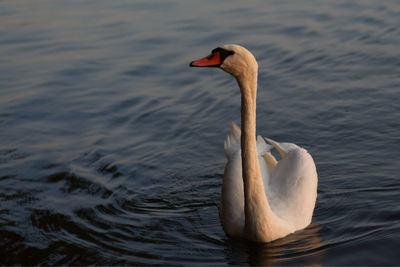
[{"xmin": 190, "ymin": 45, "xmax": 258, "ymax": 78}]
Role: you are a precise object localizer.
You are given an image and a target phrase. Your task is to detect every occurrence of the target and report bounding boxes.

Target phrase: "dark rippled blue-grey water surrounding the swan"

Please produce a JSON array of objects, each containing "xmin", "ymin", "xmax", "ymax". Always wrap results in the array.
[{"xmin": 0, "ymin": 0, "xmax": 400, "ymax": 265}]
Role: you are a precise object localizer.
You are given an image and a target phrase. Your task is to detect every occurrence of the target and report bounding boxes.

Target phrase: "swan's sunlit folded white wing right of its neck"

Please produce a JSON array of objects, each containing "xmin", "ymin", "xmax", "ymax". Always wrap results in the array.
[{"xmin": 265, "ymin": 139, "xmax": 318, "ymax": 229}]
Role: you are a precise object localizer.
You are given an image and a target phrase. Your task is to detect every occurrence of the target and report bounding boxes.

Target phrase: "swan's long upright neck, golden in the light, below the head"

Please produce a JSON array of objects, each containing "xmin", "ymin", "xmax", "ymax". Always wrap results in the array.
[{"xmin": 236, "ymin": 70, "xmax": 272, "ymax": 241}]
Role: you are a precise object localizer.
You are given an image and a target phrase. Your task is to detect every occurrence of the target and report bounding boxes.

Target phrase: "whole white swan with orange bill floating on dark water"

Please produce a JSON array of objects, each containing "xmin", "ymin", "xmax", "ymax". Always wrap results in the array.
[{"xmin": 190, "ymin": 45, "xmax": 318, "ymax": 242}]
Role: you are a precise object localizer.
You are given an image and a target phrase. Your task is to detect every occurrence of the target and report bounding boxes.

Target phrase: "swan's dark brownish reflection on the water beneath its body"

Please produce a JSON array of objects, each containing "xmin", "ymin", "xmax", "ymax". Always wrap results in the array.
[{"xmin": 227, "ymin": 224, "xmax": 325, "ymax": 266}]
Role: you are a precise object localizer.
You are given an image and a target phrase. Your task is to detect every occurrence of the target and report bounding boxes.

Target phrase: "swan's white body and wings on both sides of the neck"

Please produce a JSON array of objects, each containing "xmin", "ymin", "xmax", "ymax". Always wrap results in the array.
[{"xmin": 220, "ymin": 123, "xmax": 317, "ymax": 242}]
